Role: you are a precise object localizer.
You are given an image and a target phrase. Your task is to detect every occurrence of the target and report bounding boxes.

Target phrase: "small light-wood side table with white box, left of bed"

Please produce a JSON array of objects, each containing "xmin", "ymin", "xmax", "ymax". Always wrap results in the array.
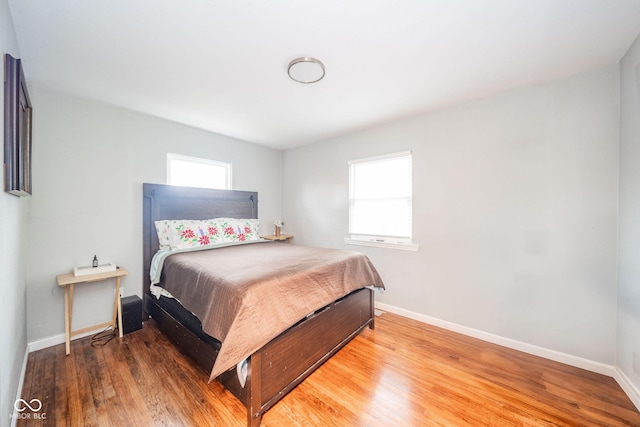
[{"xmin": 56, "ymin": 267, "xmax": 129, "ymax": 355}]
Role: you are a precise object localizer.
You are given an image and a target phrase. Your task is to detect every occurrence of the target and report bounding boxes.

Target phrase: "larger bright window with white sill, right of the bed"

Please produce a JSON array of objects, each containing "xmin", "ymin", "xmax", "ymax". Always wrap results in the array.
[{"xmin": 346, "ymin": 152, "xmax": 417, "ymax": 249}]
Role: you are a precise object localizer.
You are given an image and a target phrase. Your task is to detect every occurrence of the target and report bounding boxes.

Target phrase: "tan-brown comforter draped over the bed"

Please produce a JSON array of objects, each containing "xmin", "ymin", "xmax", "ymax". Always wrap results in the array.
[{"xmin": 160, "ymin": 243, "xmax": 384, "ymax": 380}]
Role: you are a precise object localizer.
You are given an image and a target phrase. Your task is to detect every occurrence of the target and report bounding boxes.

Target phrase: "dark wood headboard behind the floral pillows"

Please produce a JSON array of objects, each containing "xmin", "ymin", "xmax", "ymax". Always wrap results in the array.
[{"xmin": 142, "ymin": 184, "xmax": 258, "ymax": 294}]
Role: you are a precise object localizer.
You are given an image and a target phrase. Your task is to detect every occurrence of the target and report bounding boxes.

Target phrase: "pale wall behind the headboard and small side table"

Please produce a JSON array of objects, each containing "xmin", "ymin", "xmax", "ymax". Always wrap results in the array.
[{"xmin": 27, "ymin": 87, "xmax": 282, "ymax": 342}]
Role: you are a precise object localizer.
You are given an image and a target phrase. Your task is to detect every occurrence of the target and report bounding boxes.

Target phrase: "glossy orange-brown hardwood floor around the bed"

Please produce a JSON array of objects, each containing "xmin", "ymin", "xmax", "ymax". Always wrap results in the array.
[{"xmin": 18, "ymin": 313, "xmax": 640, "ymax": 427}]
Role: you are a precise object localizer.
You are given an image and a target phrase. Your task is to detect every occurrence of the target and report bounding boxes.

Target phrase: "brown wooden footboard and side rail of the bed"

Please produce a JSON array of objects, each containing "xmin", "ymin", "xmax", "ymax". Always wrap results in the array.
[{"xmin": 145, "ymin": 289, "xmax": 374, "ymax": 426}]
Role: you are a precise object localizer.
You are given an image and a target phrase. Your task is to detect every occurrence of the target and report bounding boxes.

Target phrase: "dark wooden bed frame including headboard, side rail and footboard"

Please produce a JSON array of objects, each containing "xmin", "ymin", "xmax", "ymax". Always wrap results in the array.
[{"xmin": 143, "ymin": 184, "xmax": 374, "ymax": 426}]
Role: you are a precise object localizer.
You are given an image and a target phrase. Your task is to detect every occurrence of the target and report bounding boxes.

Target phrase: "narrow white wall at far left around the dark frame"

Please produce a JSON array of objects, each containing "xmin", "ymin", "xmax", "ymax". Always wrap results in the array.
[{"xmin": 0, "ymin": 0, "xmax": 29, "ymax": 426}]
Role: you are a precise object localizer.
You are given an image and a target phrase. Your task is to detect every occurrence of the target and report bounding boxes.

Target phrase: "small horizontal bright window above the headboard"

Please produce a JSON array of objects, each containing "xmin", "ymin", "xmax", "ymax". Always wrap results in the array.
[{"xmin": 167, "ymin": 153, "xmax": 231, "ymax": 190}]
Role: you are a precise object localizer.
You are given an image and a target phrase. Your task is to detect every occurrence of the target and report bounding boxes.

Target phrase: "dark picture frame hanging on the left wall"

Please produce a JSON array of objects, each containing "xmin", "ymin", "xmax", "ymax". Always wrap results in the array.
[{"xmin": 4, "ymin": 54, "xmax": 33, "ymax": 196}]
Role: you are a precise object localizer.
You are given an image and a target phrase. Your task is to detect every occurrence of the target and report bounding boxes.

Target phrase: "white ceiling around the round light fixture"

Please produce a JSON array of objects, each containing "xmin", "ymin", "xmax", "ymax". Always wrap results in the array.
[{"xmin": 9, "ymin": 0, "xmax": 640, "ymax": 149}]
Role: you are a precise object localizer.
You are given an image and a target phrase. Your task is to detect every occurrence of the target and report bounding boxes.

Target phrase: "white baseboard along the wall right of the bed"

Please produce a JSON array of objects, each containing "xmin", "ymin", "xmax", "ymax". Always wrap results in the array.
[{"xmin": 376, "ymin": 302, "xmax": 616, "ymax": 378}]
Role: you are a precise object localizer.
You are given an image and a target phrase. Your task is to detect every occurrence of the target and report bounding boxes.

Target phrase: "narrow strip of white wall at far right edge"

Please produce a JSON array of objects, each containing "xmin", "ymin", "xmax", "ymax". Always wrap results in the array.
[{"xmin": 617, "ymin": 33, "xmax": 640, "ymax": 407}]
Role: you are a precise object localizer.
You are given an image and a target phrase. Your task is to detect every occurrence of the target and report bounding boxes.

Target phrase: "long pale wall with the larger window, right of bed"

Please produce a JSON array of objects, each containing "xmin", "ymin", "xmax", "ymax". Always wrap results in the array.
[{"xmin": 283, "ymin": 65, "xmax": 619, "ymax": 365}]
